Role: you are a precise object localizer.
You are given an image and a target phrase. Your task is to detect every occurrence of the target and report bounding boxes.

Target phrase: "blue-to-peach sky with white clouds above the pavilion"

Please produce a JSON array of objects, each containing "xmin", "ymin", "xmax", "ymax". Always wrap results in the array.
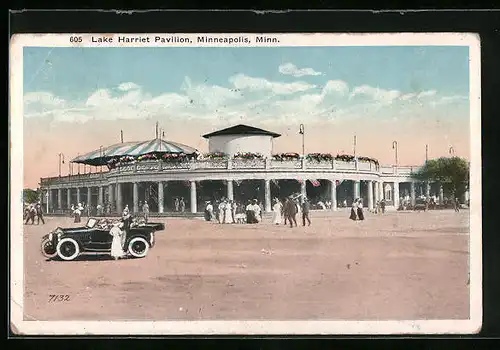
[{"xmin": 23, "ymin": 46, "xmax": 470, "ymax": 188}]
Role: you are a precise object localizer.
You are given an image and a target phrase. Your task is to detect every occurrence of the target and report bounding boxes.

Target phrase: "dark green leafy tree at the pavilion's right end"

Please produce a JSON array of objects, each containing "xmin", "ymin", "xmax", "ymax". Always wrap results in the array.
[{"xmin": 414, "ymin": 157, "xmax": 469, "ymax": 198}]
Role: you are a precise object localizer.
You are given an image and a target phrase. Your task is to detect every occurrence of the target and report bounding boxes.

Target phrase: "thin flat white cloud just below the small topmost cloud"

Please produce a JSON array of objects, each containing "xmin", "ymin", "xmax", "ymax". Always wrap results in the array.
[{"xmin": 229, "ymin": 74, "xmax": 316, "ymax": 95}]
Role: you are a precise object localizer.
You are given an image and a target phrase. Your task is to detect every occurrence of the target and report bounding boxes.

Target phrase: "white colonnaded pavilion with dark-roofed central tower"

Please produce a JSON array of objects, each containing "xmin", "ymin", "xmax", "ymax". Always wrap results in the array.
[{"xmin": 40, "ymin": 125, "xmax": 436, "ymax": 213}]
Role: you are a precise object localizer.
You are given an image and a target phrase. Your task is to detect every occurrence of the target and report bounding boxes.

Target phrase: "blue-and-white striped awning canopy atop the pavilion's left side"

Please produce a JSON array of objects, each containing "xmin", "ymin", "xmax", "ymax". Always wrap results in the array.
[{"xmin": 71, "ymin": 139, "xmax": 196, "ymax": 166}]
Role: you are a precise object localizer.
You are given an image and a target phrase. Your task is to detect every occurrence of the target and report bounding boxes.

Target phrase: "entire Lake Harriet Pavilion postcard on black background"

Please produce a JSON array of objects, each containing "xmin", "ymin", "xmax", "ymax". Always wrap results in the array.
[{"xmin": 10, "ymin": 33, "xmax": 482, "ymax": 335}]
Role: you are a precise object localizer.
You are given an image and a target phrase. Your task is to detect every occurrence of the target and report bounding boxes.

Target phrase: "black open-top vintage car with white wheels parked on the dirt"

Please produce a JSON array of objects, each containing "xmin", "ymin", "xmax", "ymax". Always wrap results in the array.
[{"xmin": 41, "ymin": 218, "xmax": 165, "ymax": 261}]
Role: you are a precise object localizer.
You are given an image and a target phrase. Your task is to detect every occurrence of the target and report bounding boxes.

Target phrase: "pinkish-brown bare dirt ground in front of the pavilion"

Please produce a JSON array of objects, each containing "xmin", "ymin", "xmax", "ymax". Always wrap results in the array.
[{"xmin": 24, "ymin": 210, "xmax": 469, "ymax": 320}]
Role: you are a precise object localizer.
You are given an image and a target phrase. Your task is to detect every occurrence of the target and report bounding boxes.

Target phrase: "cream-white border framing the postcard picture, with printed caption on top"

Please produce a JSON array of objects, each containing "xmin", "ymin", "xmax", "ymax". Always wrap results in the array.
[{"xmin": 10, "ymin": 33, "xmax": 482, "ymax": 335}]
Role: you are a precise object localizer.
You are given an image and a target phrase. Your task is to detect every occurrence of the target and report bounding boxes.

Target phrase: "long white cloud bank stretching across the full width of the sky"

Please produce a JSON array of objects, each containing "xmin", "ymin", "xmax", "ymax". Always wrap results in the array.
[{"xmin": 24, "ymin": 74, "xmax": 467, "ymax": 128}]
